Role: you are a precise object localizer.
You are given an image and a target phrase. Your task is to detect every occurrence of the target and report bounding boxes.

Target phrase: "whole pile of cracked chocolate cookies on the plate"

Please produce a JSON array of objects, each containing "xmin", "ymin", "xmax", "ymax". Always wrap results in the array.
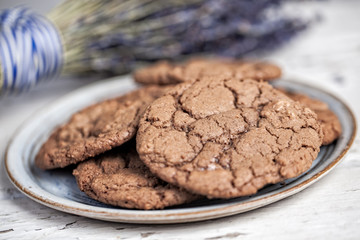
[{"xmin": 35, "ymin": 59, "xmax": 341, "ymax": 209}]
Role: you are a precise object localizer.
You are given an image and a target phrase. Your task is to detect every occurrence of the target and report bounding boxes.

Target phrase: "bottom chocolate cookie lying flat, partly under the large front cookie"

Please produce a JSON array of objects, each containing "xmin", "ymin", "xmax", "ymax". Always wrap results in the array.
[{"xmin": 73, "ymin": 144, "xmax": 199, "ymax": 210}]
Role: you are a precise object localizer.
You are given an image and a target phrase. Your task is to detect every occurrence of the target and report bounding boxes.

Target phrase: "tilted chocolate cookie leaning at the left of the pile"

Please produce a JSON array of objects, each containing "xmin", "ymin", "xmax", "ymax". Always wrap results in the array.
[{"xmin": 35, "ymin": 86, "xmax": 169, "ymax": 169}]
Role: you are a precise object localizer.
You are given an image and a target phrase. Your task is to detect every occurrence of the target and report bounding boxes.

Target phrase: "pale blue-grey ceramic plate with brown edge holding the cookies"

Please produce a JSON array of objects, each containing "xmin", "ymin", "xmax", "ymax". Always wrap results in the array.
[{"xmin": 5, "ymin": 77, "xmax": 356, "ymax": 224}]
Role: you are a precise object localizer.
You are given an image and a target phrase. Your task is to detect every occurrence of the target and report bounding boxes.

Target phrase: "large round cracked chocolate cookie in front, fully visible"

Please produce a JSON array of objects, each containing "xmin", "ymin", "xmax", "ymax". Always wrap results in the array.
[{"xmin": 137, "ymin": 77, "xmax": 323, "ymax": 198}]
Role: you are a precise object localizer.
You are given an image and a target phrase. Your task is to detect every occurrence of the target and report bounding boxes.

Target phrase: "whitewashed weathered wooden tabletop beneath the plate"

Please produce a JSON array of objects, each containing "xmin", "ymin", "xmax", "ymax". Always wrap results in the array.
[{"xmin": 0, "ymin": 1, "xmax": 360, "ymax": 240}]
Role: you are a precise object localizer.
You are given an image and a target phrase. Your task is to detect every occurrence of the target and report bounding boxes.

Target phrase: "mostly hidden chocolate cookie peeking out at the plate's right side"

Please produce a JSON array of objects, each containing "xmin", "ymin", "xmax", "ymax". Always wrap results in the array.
[{"xmin": 282, "ymin": 90, "xmax": 342, "ymax": 145}]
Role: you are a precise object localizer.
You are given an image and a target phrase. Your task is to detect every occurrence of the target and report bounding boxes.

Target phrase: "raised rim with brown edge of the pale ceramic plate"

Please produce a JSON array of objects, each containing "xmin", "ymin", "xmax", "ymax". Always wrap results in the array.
[{"xmin": 4, "ymin": 78, "xmax": 357, "ymax": 224}]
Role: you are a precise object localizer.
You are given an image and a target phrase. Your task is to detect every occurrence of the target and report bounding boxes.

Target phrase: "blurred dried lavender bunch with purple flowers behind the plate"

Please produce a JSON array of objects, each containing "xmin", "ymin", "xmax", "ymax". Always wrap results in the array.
[{"xmin": 49, "ymin": 0, "xmax": 309, "ymax": 74}]
